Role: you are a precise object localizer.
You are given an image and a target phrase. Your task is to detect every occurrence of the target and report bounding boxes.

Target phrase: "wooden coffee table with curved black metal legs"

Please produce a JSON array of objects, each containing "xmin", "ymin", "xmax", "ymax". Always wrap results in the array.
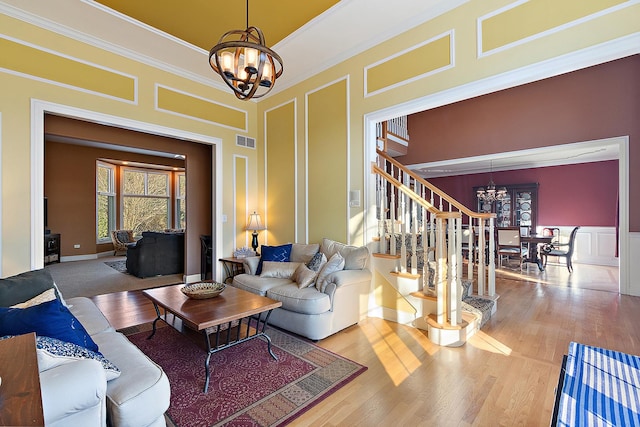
[{"xmin": 142, "ymin": 284, "xmax": 282, "ymax": 393}]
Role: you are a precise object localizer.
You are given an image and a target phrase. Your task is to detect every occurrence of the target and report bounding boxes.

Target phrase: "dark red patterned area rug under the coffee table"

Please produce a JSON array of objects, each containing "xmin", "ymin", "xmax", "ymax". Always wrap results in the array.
[{"xmin": 125, "ymin": 327, "xmax": 367, "ymax": 427}]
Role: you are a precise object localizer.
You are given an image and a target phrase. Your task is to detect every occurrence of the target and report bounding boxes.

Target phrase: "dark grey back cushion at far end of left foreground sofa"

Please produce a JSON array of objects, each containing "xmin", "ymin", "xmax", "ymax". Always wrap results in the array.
[{"xmin": 0, "ymin": 269, "xmax": 55, "ymax": 307}]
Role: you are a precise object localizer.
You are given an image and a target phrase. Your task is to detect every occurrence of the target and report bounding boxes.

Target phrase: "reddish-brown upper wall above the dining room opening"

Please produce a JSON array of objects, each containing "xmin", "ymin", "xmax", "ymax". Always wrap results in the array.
[{"xmin": 398, "ymin": 55, "xmax": 640, "ymax": 232}]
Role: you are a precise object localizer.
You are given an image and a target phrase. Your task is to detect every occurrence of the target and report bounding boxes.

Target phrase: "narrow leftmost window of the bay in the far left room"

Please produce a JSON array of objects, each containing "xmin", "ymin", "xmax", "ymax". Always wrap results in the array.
[{"xmin": 96, "ymin": 162, "xmax": 116, "ymax": 243}]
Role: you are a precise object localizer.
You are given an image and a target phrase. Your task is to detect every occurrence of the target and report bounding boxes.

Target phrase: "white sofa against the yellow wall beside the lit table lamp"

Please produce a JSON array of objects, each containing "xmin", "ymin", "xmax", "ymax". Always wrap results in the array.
[{"xmin": 232, "ymin": 238, "xmax": 371, "ymax": 340}]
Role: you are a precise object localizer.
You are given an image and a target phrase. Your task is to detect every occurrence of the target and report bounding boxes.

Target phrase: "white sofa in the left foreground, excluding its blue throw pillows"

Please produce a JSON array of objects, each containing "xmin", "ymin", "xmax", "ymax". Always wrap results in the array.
[{"xmin": 0, "ymin": 270, "xmax": 170, "ymax": 427}]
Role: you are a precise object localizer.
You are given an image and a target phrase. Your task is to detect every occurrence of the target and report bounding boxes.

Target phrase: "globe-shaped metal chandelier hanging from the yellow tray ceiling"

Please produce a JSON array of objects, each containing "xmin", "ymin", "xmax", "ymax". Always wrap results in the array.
[{"xmin": 209, "ymin": 0, "xmax": 282, "ymax": 100}]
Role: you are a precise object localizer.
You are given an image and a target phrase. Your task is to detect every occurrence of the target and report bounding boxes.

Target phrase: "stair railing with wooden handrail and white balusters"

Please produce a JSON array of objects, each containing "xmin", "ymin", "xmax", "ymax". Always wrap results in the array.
[{"xmin": 372, "ymin": 150, "xmax": 496, "ymax": 328}]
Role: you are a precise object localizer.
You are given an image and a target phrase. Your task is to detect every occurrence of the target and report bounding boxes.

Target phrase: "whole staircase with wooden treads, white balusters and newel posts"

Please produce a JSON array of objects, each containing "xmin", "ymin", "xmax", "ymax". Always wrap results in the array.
[{"xmin": 370, "ymin": 118, "xmax": 498, "ymax": 346}]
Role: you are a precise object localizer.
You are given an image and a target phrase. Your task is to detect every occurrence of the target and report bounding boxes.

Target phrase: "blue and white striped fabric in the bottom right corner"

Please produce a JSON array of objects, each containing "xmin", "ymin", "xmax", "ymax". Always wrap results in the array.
[{"xmin": 557, "ymin": 342, "xmax": 640, "ymax": 427}]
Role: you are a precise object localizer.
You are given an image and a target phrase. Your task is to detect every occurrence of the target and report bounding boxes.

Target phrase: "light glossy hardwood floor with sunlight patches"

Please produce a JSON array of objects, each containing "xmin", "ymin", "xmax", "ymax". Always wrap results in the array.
[{"xmin": 93, "ymin": 265, "xmax": 640, "ymax": 426}]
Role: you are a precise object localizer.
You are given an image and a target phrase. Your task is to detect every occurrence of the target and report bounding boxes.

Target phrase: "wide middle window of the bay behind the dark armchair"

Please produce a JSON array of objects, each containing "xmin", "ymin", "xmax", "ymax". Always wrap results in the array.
[{"xmin": 121, "ymin": 168, "xmax": 171, "ymax": 236}]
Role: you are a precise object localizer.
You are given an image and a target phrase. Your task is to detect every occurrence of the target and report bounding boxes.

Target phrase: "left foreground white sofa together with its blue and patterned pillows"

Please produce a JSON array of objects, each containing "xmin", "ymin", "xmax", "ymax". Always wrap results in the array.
[{"xmin": 0, "ymin": 270, "xmax": 170, "ymax": 427}]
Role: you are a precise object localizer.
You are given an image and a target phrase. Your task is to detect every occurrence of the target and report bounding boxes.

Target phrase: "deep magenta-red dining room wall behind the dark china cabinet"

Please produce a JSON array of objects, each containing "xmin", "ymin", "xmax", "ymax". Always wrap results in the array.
[{"xmin": 429, "ymin": 160, "xmax": 618, "ymax": 227}]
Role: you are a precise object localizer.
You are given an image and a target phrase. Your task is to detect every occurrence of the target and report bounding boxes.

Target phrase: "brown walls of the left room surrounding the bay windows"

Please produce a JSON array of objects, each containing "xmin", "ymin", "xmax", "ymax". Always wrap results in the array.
[{"xmin": 44, "ymin": 116, "xmax": 212, "ymax": 275}]
